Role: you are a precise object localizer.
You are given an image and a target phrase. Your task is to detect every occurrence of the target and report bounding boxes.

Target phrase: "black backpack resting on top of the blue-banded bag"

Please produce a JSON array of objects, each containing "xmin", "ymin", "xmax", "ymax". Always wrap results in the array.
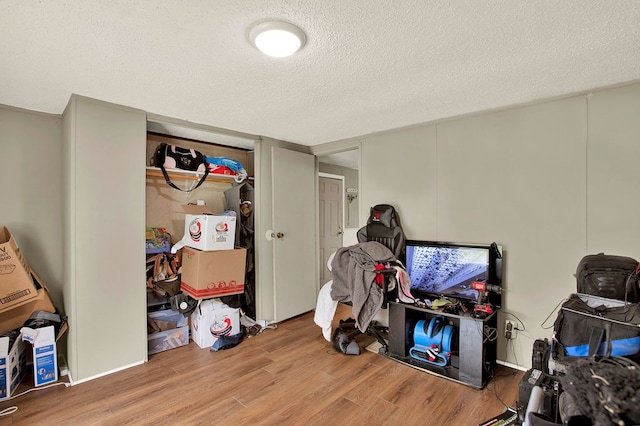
[{"xmin": 576, "ymin": 253, "xmax": 639, "ymax": 303}]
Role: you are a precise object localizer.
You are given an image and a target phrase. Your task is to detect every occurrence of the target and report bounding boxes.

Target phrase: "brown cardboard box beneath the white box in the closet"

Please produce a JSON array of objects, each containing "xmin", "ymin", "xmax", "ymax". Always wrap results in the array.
[{"xmin": 180, "ymin": 247, "xmax": 247, "ymax": 300}]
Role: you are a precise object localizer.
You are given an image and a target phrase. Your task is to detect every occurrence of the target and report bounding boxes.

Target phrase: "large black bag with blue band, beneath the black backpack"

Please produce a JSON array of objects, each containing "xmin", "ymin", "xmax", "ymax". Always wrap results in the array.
[{"xmin": 552, "ymin": 294, "xmax": 640, "ymax": 361}]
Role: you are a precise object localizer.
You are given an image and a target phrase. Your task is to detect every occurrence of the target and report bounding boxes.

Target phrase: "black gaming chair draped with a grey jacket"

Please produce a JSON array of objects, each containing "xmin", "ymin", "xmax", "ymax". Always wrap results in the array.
[{"xmin": 334, "ymin": 204, "xmax": 405, "ymax": 354}]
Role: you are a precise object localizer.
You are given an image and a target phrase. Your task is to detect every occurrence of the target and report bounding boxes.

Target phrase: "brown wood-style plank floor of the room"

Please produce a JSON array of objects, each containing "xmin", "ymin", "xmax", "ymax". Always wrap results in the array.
[{"xmin": 0, "ymin": 305, "xmax": 524, "ymax": 426}]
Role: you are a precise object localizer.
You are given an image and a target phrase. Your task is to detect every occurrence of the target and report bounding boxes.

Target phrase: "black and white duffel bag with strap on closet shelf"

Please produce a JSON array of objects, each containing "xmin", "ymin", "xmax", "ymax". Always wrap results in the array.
[{"xmin": 153, "ymin": 142, "xmax": 209, "ymax": 192}]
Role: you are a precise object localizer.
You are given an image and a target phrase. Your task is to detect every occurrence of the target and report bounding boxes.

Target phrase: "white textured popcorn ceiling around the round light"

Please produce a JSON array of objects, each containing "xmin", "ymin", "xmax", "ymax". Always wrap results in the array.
[{"xmin": 0, "ymin": 0, "xmax": 640, "ymax": 145}]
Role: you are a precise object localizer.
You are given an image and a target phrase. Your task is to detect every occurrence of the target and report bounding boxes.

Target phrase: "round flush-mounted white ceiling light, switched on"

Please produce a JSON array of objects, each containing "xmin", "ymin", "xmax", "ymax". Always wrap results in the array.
[{"xmin": 249, "ymin": 21, "xmax": 306, "ymax": 58}]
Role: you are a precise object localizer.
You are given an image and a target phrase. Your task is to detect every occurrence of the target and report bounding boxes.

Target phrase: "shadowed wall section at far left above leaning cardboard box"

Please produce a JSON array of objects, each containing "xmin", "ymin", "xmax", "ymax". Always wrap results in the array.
[{"xmin": 0, "ymin": 106, "xmax": 63, "ymax": 309}]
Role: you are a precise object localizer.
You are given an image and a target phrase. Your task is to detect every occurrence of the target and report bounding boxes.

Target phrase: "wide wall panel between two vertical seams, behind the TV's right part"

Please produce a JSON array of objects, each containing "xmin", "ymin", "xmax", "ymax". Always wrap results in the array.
[{"xmin": 437, "ymin": 97, "xmax": 586, "ymax": 366}]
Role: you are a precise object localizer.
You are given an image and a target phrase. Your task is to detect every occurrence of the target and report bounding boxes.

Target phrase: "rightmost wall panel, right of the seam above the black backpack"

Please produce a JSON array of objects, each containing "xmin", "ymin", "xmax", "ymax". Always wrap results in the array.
[{"xmin": 586, "ymin": 84, "xmax": 640, "ymax": 253}]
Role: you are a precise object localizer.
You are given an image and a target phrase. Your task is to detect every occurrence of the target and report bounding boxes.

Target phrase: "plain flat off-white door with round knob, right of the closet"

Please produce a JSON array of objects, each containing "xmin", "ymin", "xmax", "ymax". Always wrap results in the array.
[{"xmin": 271, "ymin": 147, "xmax": 318, "ymax": 321}]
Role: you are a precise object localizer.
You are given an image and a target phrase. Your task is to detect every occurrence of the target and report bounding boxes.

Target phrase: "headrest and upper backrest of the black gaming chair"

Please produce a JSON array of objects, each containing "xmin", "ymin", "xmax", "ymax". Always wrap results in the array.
[{"xmin": 356, "ymin": 204, "xmax": 405, "ymax": 261}]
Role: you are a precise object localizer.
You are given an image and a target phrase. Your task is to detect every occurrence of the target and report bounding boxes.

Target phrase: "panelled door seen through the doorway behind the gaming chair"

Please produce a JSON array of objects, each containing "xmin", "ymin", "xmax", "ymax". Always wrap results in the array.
[{"xmin": 318, "ymin": 176, "xmax": 344, "ymax": 285}]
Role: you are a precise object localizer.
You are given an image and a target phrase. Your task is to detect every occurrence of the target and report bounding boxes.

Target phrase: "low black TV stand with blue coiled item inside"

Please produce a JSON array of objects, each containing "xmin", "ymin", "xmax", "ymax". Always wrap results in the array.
[{"xmin": 385, "ymin": 302, "xmax": 497, "ymax": 389}]
